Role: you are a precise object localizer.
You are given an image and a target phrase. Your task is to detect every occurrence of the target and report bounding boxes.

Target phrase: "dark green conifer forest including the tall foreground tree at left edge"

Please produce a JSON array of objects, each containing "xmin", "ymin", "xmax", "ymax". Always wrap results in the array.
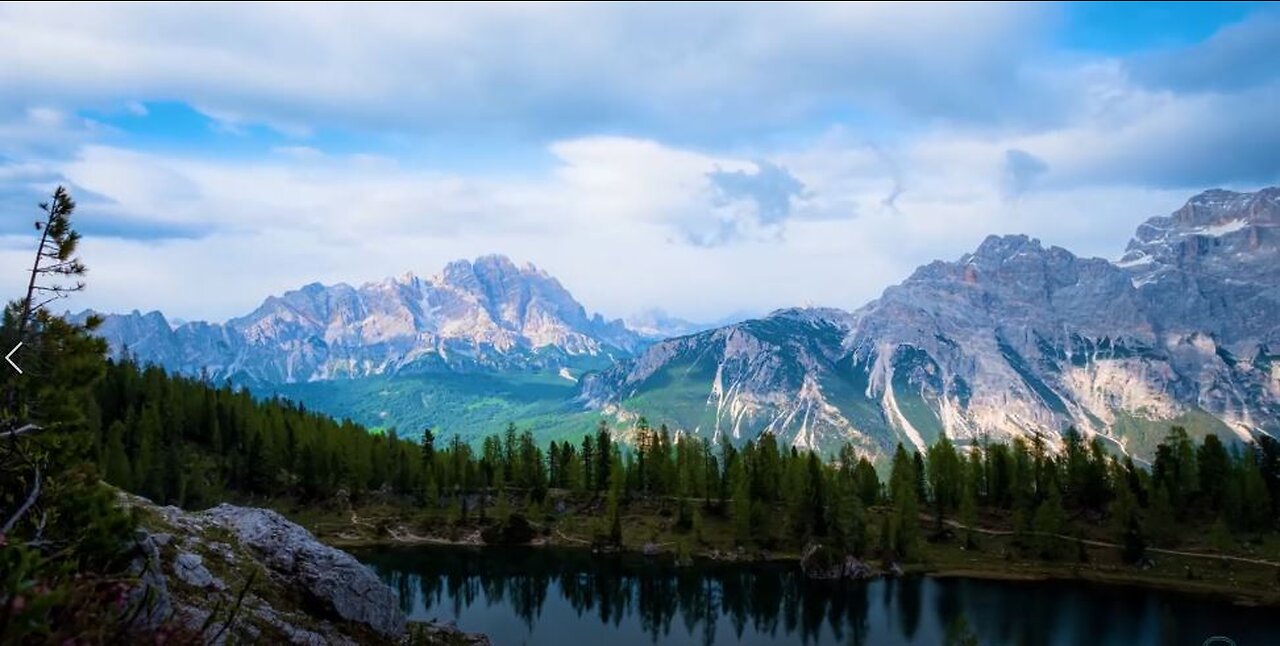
[{"xmin": 0, "ymin": 188, "xmax": 1280, "ymax": 642}]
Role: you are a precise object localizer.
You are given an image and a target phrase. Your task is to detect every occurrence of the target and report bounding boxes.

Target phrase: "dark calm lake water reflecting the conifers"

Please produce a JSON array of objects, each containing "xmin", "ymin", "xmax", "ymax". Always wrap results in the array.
[{"xmin": 355, "ymin": 546, "xmax": 1280, "ymax": 646}]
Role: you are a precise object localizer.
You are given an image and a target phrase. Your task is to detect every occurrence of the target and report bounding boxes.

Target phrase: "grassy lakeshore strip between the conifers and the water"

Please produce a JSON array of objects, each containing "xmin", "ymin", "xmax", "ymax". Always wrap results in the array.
[{"xmin": 264, "ymin": 491, "xmax": 1280, "ymax": 605}]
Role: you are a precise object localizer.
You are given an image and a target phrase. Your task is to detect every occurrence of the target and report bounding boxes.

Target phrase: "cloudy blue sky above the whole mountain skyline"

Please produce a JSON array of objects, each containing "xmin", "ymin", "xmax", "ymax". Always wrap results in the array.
[{"xmin": 0, "ymin": 3, "xmax": 1280, "ymax": 321}]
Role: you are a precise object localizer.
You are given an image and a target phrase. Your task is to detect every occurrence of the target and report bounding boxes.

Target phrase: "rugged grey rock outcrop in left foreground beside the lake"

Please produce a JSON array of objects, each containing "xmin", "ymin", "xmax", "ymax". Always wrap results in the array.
[{"xmin": 122, "ymin": 495, "xmax": 407, "ymax": 645}]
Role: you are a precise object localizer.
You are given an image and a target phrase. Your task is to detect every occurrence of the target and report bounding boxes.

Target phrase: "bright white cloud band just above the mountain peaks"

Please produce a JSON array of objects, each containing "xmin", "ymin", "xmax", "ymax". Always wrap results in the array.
[{"xmin": 3, "ymin": 124, "xmax": 1218, "ymax": 320}]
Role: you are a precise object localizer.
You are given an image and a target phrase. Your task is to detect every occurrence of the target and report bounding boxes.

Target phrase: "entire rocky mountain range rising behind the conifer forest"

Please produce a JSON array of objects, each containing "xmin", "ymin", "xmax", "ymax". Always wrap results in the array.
[{"xmin": 85, "ymin": 188, "xmax": 1280, "ymax": 457}]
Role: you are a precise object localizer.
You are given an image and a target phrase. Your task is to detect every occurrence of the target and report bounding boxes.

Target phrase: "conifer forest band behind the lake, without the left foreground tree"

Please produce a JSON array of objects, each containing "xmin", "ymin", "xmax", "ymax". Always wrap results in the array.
[{"xmin": 87, "ymin": 353, "xmax": 1280, "ymax": 562}]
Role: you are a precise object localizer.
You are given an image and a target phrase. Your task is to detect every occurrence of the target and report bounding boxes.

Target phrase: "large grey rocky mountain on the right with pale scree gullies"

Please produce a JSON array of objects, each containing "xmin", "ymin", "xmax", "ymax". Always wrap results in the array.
[{"xmin": 580, "ymin": 188, "xmax": 1280, "ymax": 457}]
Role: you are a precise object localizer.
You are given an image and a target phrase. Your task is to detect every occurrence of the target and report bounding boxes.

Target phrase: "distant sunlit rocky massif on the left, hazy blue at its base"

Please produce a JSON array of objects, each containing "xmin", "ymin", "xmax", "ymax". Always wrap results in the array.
[{"xmin": 79, "ymin": 256, "xmax": 640, "ymax": 385}]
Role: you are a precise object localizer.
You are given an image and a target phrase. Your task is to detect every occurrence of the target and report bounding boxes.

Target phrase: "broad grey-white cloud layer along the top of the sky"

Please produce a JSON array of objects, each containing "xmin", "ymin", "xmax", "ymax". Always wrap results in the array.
[{"xmin": 0, "ymin": 4, "xmax": 1053, "ymax": 141}]
